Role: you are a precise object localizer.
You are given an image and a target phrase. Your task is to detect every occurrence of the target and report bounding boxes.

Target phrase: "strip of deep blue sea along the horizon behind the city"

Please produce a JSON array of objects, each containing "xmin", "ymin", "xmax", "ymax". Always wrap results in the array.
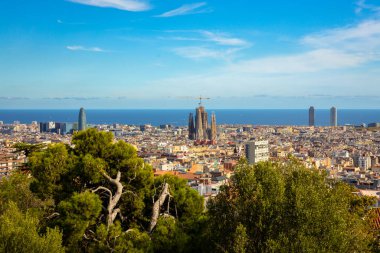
[{"xmin": 0, "ymin": 109, "xmax": 380, "ymax": 126}]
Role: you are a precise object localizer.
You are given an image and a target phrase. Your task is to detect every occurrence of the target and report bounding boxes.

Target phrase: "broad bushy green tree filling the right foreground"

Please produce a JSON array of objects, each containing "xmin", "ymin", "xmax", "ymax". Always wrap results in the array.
[{"xmin": 207, "ymin": 161, "xmax": 373, "ymax": 252}]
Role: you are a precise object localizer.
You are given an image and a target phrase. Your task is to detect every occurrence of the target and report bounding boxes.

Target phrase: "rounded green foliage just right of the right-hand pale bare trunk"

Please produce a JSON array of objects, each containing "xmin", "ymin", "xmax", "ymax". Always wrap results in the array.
[{"xmin": 149, "ymin": 175, "xmax": 204, "ymax": 252}]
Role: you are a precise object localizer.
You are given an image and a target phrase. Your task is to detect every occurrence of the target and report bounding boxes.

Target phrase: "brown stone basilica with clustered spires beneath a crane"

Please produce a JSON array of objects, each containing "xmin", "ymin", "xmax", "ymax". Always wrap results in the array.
[{"xmin": 189, "ymin": 104, "xmax": 216, "ymax": 141}]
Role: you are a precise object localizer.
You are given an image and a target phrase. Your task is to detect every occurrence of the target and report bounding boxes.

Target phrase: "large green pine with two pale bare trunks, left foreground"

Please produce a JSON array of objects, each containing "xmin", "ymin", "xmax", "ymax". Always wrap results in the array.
[{"xmin": 25, "ymin": 129, "xmax": 204, "ymax": 252}]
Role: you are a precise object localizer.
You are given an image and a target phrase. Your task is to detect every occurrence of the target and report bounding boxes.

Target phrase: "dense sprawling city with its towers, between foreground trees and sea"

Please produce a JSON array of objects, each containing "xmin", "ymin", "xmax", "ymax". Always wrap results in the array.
[{"xmin": 0, "ymin": 104, "xmax": 380, "ymax": 201}]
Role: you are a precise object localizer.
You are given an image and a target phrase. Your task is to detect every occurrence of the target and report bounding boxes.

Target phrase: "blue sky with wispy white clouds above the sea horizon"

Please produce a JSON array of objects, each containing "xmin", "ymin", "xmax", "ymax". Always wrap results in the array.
[{"xmin": 0, "ymin": 0, "xmax": 380, "ymax": 109}]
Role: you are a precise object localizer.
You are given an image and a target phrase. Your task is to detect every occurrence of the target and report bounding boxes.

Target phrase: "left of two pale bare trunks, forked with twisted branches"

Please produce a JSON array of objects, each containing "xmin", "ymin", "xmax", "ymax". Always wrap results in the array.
[{"xmin": 93, "ymin": 171, "xmax": 123, "ymax": 229}]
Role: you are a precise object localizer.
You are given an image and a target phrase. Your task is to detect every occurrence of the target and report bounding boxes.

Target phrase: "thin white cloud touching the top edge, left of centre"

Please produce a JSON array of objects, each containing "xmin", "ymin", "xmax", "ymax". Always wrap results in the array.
[{"xmin": 67, "ymin": 0, "xmax": 151, "ymax": 11}]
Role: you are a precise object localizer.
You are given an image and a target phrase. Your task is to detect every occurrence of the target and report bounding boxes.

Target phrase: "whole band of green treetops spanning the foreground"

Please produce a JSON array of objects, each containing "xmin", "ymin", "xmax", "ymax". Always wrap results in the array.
[{"xmin": 0, "ymin": 129, "xmax": 379, "ymax": 253}]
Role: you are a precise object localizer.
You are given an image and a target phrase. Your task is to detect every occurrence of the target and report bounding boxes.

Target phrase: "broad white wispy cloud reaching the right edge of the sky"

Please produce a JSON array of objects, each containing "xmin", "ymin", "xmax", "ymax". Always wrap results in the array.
[{"xmin": 228, "ymin": 19, "xmax": 380, "ymax": 74}]
